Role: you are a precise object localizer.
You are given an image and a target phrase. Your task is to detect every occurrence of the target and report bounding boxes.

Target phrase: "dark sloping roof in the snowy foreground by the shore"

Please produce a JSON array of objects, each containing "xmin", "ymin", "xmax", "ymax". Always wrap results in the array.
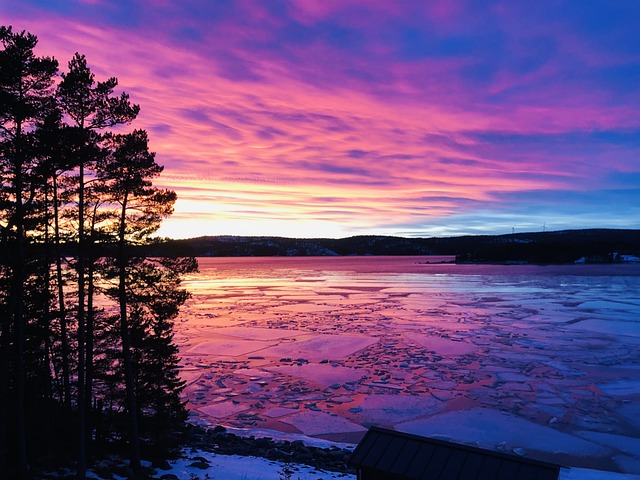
[{"xmin": 349, "ymin": 427, "xmax": 560, "ymax": 480}]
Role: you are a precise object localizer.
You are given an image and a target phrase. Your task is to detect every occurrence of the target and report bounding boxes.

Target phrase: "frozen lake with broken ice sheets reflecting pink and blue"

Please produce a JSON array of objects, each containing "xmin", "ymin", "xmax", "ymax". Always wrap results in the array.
[{"xmin": 176, "ymin": 257, "xmax": 640, "ymax": 474}]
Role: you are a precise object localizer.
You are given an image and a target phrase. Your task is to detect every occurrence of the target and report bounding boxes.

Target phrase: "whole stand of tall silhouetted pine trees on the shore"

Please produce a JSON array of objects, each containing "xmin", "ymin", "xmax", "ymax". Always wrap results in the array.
[{"xmin": 0, "ymin": 26, "xmax": 197, "ymax": 478}]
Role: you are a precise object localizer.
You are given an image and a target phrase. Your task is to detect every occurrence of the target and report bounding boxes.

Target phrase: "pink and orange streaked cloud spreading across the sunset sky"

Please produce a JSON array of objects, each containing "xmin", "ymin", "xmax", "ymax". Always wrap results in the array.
[{"xmin": 2, "ymin": 1, "xmax": 640, "ymax": 234}]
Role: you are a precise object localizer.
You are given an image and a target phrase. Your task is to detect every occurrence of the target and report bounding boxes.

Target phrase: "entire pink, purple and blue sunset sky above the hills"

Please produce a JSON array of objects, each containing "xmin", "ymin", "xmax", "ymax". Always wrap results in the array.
[{"xmin": 0, "ymin": 0, "xmax": 640, "ymax": 238}]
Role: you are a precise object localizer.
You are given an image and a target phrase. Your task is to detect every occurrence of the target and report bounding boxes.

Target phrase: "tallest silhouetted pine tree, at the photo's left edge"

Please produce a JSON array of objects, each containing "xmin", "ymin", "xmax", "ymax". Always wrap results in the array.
[{"xmin": 0, "ymin": 27, "xmax": 58, "ymax": 478}]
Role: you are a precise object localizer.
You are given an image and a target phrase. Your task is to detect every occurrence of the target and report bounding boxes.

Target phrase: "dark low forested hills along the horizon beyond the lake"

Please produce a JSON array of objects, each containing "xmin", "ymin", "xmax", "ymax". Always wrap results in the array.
[{"xmin": 144, "ymin": 229, "xmax": 640, "ymax": 263}]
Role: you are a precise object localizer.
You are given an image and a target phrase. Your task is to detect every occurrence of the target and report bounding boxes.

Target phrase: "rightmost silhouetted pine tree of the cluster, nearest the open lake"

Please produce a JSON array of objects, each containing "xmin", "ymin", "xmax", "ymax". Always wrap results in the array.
[{"xmin": 97, "ymin": 130, "xmax": 197, "ymax": 468}]
